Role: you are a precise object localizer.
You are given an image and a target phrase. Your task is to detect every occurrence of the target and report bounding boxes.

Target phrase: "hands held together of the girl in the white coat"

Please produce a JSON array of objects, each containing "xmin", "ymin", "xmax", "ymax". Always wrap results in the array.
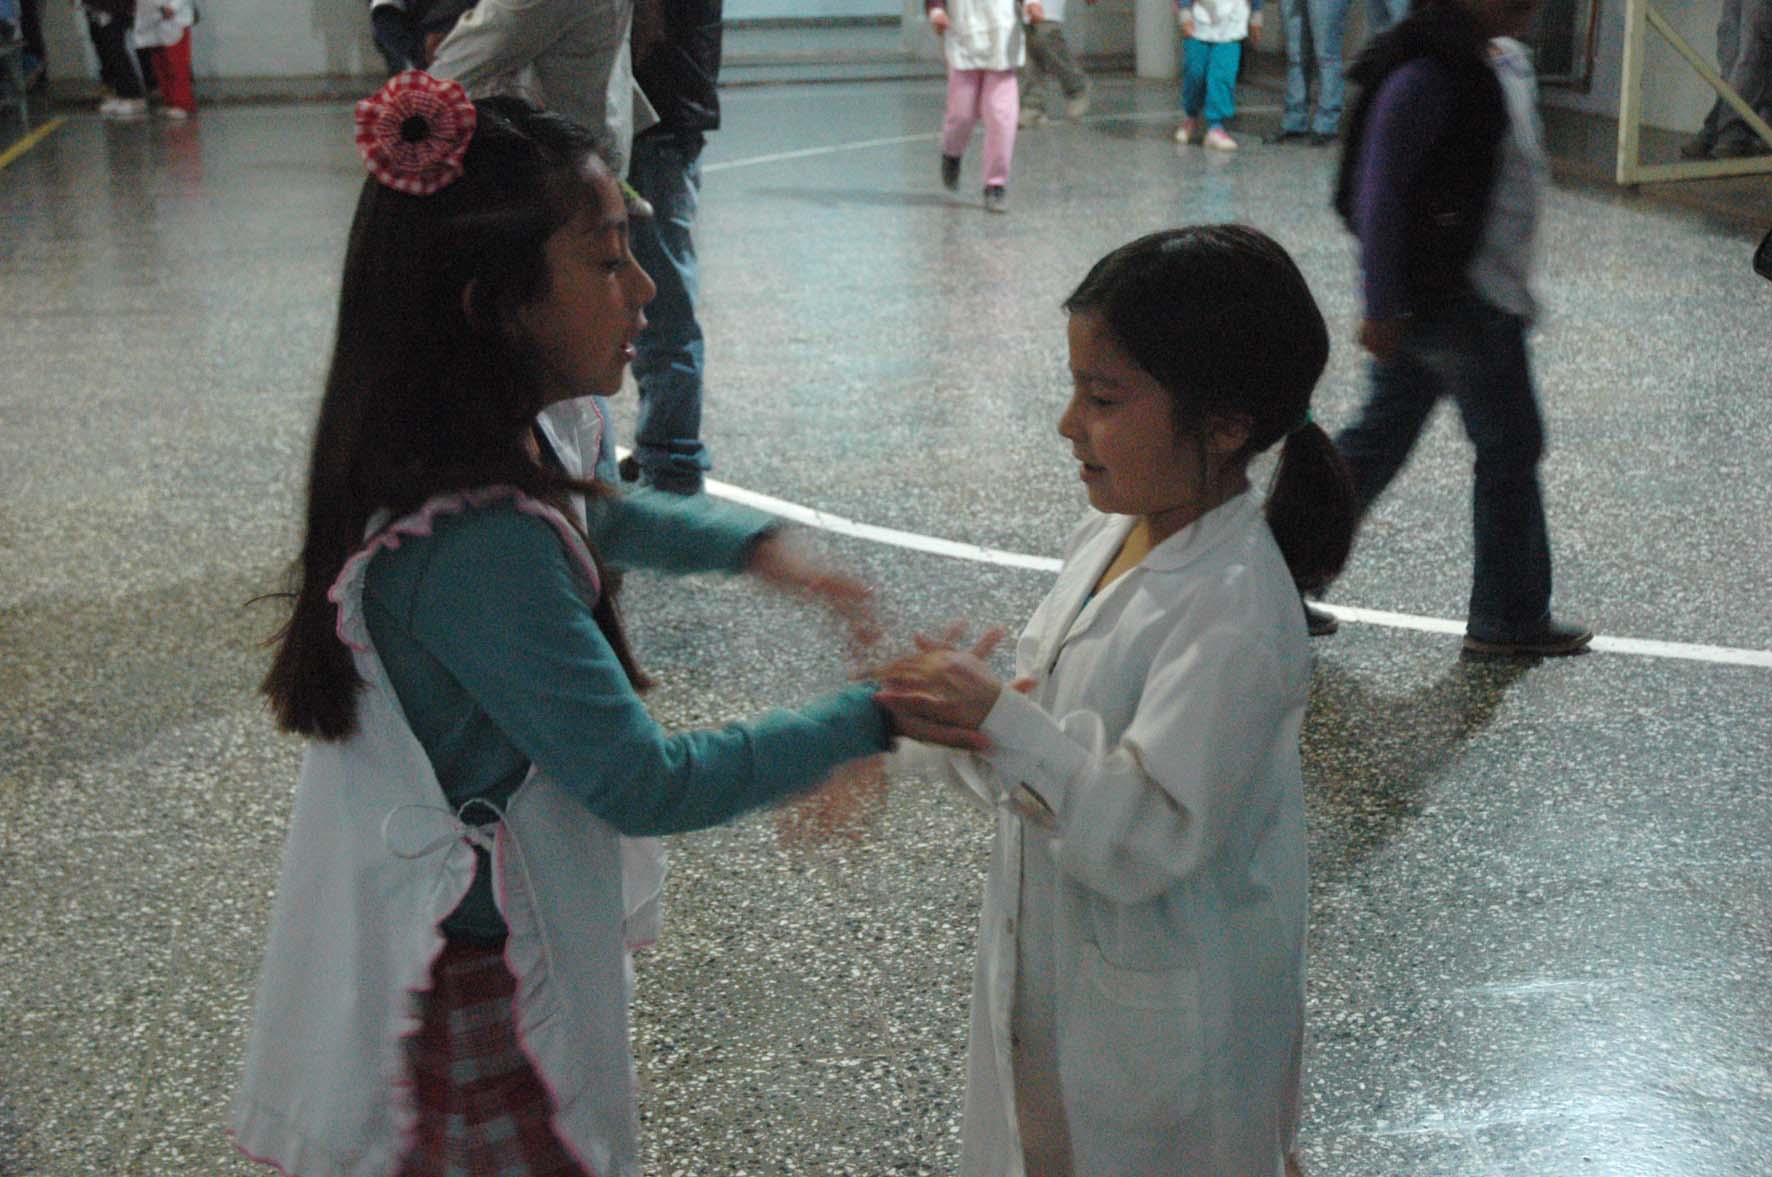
[{"xmin": 868, "ymin": 629, "xmax": 1021, "ymax": 752}]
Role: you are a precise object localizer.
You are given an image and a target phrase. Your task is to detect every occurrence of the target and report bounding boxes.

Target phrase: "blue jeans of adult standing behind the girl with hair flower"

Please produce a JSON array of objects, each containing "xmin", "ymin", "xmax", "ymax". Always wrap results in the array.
[{"xmin": 627, "ymin": 135, "xmax": 712, "ymax": 495}]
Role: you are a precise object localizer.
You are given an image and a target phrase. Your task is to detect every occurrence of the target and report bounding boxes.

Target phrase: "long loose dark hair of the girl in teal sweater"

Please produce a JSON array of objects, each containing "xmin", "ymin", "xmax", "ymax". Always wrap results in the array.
[{"xmin": 259, "ymin": 97, "xmax": 645, "ymax": 739}]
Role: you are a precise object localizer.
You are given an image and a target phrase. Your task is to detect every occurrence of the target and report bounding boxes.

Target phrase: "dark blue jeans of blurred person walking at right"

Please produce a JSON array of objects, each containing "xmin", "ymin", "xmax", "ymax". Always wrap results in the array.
[{"xmin": 1336, "ymin": 294, "xmax": 1551, "ymax": 642}]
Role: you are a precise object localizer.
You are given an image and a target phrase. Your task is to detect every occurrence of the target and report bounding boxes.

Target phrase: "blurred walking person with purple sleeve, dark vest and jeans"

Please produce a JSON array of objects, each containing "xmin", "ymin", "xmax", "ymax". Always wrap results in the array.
[{"xmin": 1313, "ymin": 0, "xmax": 1593, "ymax": 656}]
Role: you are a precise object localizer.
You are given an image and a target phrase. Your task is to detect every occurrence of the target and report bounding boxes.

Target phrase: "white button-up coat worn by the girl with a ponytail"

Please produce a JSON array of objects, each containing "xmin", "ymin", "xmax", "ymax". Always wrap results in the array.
[{"xmin": 898, "ymin": 493, "xmax": 1310, "ymax": 1177}]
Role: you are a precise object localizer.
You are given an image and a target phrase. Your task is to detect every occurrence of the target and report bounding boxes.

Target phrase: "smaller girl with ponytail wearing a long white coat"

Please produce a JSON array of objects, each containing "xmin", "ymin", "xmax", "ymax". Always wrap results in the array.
[{"xmin": 877, "ymin": 225, "xmax": 1354, "ymax": 1177}]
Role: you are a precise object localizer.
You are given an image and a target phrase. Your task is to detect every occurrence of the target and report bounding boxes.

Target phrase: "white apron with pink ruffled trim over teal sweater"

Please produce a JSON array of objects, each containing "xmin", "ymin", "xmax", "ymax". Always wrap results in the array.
[{"xmin": 229, "ymin": 401, "xmax": 663, "ymax": 1177}]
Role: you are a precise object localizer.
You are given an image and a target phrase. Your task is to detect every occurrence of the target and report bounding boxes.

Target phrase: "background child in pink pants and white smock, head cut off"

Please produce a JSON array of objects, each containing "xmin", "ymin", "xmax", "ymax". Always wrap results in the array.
[{"xmin": 925, "ymin": 0, "xmax": 1045, "ymax": 213}]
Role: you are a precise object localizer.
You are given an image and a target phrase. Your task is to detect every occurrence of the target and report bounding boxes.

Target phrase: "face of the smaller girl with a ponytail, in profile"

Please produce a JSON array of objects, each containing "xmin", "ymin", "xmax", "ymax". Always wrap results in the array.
[{"xmin": 1058, "ymin": 310, "xmax": 1228, "ymax": 535}]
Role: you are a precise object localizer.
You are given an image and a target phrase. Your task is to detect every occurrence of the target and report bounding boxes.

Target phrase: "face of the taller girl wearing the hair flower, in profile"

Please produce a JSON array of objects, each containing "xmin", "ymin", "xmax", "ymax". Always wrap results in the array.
[{"xmin": 517, "ymin": 174, "xmax": 657, "ymax": 404}]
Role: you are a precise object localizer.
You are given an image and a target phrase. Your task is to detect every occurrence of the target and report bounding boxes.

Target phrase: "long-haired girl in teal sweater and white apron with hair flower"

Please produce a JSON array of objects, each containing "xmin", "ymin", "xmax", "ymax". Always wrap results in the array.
[{"xmin": 234, "ymin": 71, "xmax": 914, "ymax": 1177}]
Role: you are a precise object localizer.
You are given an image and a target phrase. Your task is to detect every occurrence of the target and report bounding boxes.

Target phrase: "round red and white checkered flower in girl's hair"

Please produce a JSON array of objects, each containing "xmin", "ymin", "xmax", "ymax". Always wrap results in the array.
[{"xmin": 356, "ymin": 69, "xmax": 477, "ymax": 197}]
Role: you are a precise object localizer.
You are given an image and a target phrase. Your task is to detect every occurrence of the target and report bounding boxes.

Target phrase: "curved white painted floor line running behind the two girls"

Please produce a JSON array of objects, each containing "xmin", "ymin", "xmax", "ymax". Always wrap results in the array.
[{"xmin": 673, "ymin": 460, "xmax": 1772, "ymax": 670}]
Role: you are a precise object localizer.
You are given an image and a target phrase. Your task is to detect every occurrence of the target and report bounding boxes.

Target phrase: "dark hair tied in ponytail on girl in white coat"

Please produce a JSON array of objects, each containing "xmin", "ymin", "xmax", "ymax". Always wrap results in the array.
[{"xmin": 1065, "ymin": 225, "xmax": 1359, "ymax": 590}]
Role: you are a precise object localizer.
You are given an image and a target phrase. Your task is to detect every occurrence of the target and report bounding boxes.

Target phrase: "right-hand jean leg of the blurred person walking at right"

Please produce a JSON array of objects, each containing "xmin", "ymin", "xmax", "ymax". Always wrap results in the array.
[{"xmin": 1451, "ymin": 300, "xmax": 1551, "ymax": 642}]
